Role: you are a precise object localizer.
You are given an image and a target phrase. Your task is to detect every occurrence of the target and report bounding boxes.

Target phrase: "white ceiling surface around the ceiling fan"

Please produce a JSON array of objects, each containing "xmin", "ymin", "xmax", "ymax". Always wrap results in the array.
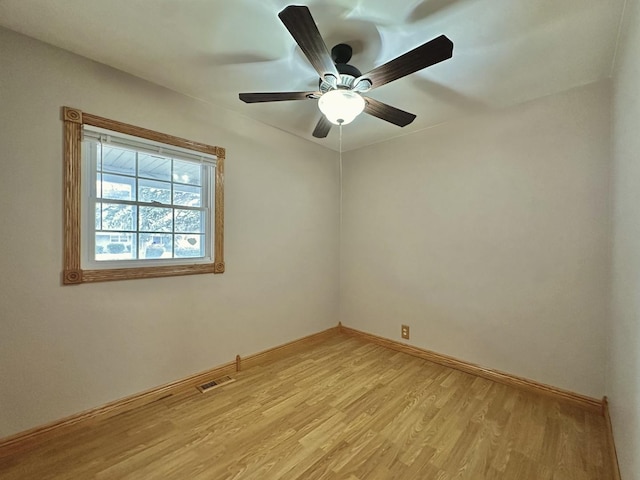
[{"xmin": 0, "ymin": 0, "xmax": 624, "ymax": 150}]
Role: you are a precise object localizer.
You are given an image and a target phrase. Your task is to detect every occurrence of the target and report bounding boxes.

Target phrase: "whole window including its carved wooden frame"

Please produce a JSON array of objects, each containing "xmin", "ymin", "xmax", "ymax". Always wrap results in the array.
[{"xmin": 63, "ymin": 107, "xmax": 225, "ymax": 284}]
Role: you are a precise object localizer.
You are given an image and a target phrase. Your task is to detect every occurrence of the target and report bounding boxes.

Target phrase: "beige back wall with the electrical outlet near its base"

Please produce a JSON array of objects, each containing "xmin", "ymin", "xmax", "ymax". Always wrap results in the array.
[{"xmin": 341, "ymin": 82, "xmax": 610, "ymax": 397}]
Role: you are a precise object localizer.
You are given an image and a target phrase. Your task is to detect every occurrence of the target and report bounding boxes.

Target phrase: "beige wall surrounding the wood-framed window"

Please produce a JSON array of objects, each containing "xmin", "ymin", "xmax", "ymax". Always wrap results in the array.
[{"xmin": 0, "ymin": 30, "xmax": 339, "ymax": 437}]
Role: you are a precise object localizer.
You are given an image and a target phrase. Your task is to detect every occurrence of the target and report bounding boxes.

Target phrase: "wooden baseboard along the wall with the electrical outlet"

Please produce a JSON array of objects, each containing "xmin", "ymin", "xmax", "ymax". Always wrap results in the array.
[{"xmin": 339, "ymin": 325, "xmax": 603, "ymax": 413}]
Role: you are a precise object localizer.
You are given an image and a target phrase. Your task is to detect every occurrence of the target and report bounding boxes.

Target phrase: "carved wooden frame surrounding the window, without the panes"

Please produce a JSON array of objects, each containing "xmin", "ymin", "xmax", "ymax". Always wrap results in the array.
[{"xmin": 62, "ymin": 107, "xmax": 225, "ymax": 285}]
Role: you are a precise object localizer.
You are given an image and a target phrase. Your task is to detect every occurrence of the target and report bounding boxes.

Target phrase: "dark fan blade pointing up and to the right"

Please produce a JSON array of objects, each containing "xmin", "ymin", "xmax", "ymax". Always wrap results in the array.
[{"xmin": 354, "ymin": 35, "xmax": 453, "ymax": 88}]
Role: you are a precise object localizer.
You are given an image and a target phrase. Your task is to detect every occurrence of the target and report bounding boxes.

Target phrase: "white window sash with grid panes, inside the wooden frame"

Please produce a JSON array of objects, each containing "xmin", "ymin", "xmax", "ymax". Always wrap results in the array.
[{"xmin": 81, "ymin": 125, "xmax": 216, "ymax": 268}]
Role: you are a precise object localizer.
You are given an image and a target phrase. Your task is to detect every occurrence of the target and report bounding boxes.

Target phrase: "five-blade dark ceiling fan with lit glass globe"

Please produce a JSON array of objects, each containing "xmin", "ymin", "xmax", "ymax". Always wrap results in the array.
[{"xmin": 239, "ymin": 5, "xmax": 453, "ymax": 138}]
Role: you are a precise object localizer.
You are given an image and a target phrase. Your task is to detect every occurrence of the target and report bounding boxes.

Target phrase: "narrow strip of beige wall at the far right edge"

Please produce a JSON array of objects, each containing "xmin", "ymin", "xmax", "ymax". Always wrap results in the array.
[{"xmin": 607, "ymin": 0, "xmax": 640, "ymax": 480}]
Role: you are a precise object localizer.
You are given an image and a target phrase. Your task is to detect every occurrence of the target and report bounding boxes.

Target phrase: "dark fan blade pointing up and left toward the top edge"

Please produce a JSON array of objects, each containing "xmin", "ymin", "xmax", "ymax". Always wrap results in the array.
[{"xmin": 278, "ymin": 5, "xmax": 340, "ymax": 78}]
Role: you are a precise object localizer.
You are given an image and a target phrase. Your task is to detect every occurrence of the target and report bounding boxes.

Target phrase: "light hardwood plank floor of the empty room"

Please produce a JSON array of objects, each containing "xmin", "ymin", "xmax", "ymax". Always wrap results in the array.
[{"xmin": 0, "ymin": 335, "xmax": 612, "ymax": 480}]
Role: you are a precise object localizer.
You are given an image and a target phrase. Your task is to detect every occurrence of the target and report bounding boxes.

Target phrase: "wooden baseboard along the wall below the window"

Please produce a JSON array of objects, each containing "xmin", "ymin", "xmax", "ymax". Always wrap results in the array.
[{"xmin": 0, "ymin": 326, "xmax": 339, "ymax": 458}]
